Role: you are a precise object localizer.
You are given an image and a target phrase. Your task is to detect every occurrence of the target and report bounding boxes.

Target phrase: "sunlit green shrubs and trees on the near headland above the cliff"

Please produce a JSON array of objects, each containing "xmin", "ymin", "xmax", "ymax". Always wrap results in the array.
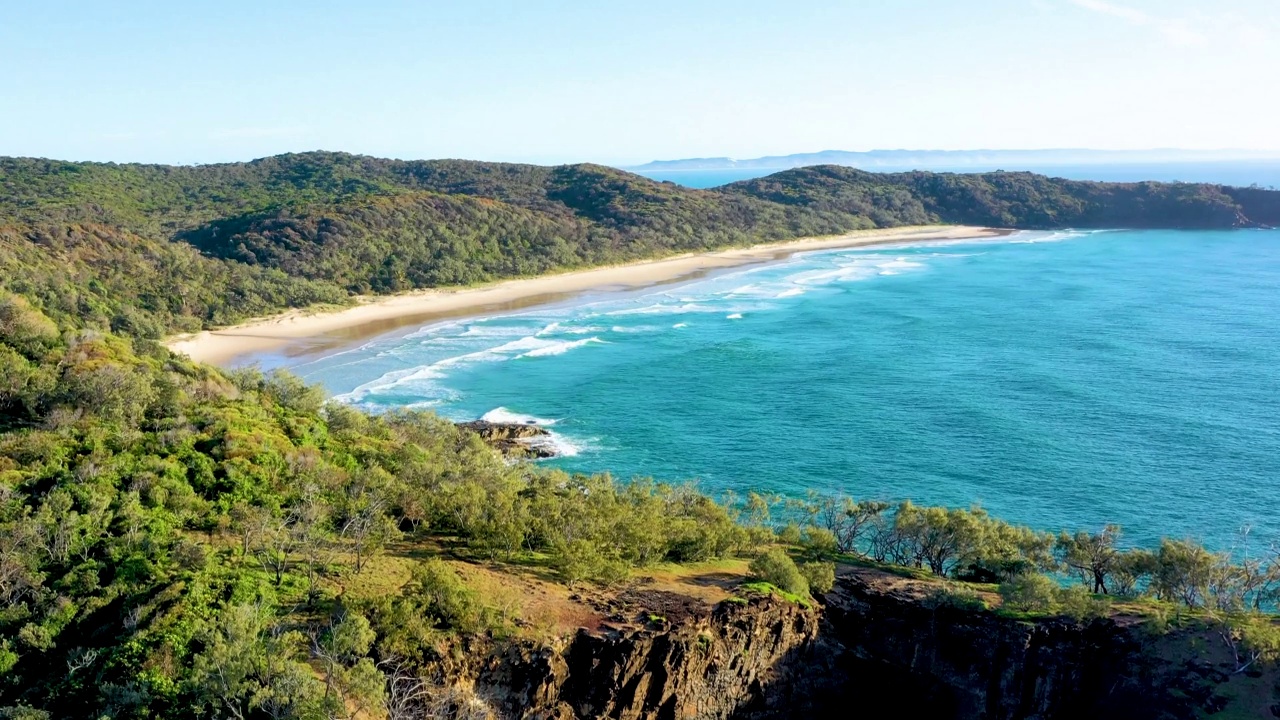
[{"xmin": 0, "ymin": 284, "xmax": 1280, "ymax": 717}]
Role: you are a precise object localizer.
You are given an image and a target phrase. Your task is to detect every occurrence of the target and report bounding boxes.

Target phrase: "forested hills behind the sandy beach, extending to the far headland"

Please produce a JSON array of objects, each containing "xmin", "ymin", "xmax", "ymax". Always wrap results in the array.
[{"xmin": 0, "ymin": 152, "xmax": 1280, "ymax": 338}]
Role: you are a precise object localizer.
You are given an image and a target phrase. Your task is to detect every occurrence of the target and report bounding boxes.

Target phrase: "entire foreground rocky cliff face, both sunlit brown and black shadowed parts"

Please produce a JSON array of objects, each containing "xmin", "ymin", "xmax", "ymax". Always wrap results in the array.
[{"xmin": 432, "ymin": 573, "xmax": 1280, "ymax": 720}]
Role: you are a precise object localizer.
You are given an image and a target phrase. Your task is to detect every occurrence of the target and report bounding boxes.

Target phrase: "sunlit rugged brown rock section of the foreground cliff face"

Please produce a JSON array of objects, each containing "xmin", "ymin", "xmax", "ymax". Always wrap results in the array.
[{"xmin": 445, "ymin": 598, "xmax": 820, "ymax": 720}]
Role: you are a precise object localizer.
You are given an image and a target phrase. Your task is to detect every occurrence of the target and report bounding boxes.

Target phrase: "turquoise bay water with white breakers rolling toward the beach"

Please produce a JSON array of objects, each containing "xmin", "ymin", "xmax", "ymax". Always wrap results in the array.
[{"xmin": 296, "ymin": 231, "xmax": 1280, "ymax": 547}]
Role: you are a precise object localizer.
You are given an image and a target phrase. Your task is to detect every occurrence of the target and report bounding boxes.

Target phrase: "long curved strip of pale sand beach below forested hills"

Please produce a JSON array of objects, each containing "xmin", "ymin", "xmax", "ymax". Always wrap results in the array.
[{"xmin": 166, "ymin": 225, "xmax": 1007, "ymax": 365}]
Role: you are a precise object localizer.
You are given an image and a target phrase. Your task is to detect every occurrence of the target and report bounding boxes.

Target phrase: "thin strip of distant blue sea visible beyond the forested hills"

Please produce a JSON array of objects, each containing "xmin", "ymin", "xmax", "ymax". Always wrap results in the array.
[{"xmin": 641, "ymin": 160, "xmax": 1280, "ymax": 187}]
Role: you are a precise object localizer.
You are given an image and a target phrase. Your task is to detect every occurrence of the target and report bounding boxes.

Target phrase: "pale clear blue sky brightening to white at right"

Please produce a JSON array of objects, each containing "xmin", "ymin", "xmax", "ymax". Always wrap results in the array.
[{"xmin": 0, "ymin": 0, "xmax": 1280, "ymax": 163}]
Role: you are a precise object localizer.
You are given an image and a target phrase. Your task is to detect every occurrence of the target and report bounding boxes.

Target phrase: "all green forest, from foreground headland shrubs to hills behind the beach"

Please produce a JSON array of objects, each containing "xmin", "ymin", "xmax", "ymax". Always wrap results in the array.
[{"xmin": 0, "ymin": 154, "xmax": 1280, "ymax": 720}]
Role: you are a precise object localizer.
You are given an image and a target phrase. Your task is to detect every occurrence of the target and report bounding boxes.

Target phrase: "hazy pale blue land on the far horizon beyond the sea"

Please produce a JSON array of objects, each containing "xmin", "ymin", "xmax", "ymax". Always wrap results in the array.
[{"xmin": 626, "ymin": 149, "xmax": 1280, "ymax": 173}]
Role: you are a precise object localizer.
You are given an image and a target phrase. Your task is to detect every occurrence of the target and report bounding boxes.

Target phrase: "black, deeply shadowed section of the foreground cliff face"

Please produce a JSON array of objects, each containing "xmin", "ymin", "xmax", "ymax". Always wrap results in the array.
[{"xmin": 818, "ymin": 566, "xmax": 1226, "ymax": 720}]
